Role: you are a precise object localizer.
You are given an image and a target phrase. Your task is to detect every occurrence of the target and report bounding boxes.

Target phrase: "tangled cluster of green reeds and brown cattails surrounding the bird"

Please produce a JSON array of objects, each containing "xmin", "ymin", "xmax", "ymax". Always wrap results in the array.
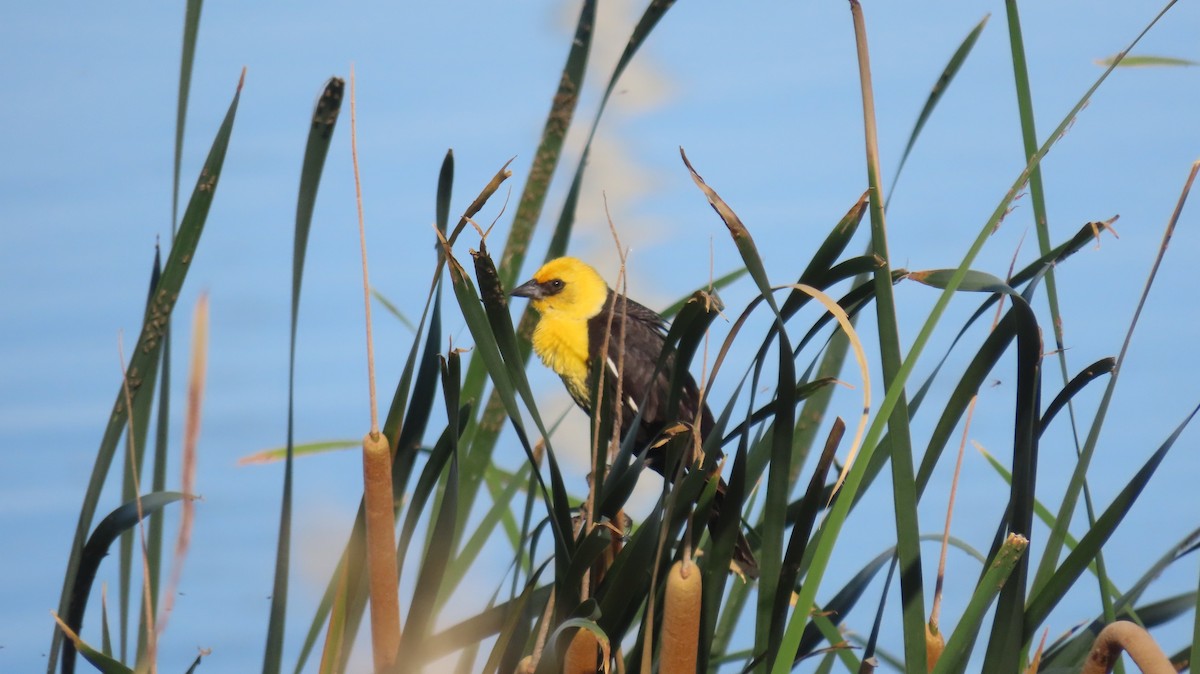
[{"xmin": 50, "ymin": 0, "xmax": 1200, "ymax": 674}]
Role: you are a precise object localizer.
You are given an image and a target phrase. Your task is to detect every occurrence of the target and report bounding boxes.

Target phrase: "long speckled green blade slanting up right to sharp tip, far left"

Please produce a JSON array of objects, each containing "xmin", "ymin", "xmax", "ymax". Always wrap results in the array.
[{"xmin": 47, "ymin": 71, "xmax": 245, "ymax": 674}]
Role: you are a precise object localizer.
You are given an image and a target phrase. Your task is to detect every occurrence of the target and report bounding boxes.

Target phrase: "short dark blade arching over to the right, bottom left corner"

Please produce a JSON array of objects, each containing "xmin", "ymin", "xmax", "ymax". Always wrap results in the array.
[{"xmin": 62, "ymin": 492, "xmax": 186, "ymax": 674}]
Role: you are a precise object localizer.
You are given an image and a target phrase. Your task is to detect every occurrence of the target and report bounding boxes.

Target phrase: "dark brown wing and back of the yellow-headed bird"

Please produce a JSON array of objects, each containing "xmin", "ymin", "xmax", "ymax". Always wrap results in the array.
[{"xmin": 588, "ymin": 285, "xmax": 713, "ymax": 471}]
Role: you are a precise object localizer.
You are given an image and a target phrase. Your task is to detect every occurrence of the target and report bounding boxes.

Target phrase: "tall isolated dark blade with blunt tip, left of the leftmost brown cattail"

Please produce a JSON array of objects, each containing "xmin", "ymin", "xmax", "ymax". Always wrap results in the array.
[{"xmin": 263, "ymin": 77, "xmax": 346, "ymax": 674}]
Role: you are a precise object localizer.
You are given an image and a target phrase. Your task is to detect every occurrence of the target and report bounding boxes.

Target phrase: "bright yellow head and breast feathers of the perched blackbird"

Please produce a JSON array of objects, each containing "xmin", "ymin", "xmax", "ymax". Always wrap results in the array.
[{"xmin": 530, "ymin": 258, "xmax": 608, "ymax": 401}]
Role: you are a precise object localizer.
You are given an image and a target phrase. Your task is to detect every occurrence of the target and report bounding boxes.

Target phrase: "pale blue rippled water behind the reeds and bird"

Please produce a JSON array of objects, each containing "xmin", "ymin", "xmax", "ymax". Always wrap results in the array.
[{"xmin": 0, "ymin": 1, "xmax": 1200, "ymax": 672}]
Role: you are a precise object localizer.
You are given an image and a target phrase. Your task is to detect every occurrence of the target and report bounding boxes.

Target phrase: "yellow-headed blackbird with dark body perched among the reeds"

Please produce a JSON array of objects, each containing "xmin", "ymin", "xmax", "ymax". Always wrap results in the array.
[{"xmin": 512, "ymin": 258, "xmax": 758, "ymax": 578}]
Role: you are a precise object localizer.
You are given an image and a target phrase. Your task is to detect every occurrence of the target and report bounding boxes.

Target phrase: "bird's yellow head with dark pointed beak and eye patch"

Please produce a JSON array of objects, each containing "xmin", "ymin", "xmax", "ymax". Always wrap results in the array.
[{"xmin": 511, "ymin": 258, "xmax": 608, "ymax": 320}]
